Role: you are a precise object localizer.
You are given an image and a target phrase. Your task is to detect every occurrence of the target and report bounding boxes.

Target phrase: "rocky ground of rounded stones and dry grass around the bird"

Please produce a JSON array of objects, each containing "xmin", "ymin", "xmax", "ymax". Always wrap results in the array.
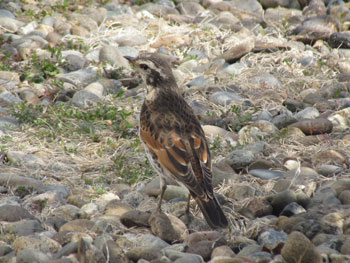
[{"xmin": 0, "ymin": 0, "xmax": 350, "ymax": 263}]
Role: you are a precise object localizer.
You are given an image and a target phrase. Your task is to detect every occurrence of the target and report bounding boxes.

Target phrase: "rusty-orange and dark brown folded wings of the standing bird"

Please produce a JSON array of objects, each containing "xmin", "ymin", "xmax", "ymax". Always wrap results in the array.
[{"xmin": 140, "ymin": 123, "xmax": 213, "ymax": 199}]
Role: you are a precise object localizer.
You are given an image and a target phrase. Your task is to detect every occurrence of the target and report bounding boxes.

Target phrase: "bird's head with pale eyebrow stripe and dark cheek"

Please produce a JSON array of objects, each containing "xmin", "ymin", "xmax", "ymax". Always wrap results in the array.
[{"xmin": 125, "ymin": 53, "xmax": 178, "ymax": 97}]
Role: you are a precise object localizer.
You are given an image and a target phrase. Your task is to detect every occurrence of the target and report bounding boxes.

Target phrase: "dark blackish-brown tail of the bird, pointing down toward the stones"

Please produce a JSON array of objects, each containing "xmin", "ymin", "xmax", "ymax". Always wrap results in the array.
[{"xmin": 193, "ymin": 196, "xmax": 228, "ymax": 228}]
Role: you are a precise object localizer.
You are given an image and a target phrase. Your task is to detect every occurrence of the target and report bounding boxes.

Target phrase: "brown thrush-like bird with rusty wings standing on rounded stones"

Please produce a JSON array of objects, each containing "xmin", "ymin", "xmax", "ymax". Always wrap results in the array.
[{"xmin": 126, "ymin": 53, "xmax": 228, "ymax": 229}]
